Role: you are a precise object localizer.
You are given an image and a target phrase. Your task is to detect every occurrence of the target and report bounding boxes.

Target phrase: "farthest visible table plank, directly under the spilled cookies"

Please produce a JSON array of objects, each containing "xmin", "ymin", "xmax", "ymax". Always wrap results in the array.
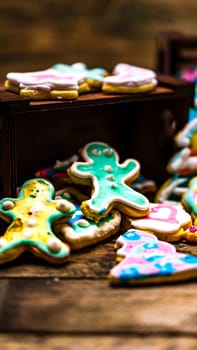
[{"xmin": 0, "ymin": 237, "xmax": 197, "ymax": 279}]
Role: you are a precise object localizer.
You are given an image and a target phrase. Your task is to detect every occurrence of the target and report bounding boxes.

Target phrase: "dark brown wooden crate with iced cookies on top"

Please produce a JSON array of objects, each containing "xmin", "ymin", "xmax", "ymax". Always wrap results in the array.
[{"xmin": 0, "ymin": 76, "xmax": 194, "ymax": 196}]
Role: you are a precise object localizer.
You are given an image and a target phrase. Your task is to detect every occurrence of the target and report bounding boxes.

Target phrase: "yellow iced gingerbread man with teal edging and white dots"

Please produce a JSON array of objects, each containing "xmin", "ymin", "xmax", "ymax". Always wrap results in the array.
[{"xmin": 0, "ymin": 179, "xmax": 75, "ymax": 264}]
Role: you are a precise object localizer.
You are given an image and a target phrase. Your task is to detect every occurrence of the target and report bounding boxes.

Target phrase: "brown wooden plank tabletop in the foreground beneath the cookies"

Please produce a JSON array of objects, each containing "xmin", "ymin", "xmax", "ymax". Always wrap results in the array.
[{"xmin": 0, "ymin": 237, "xmax": 197, "ymax": 350}]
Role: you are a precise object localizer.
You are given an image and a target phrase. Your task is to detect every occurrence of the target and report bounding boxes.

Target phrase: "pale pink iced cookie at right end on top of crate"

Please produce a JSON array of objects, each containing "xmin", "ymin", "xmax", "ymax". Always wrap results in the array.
[{"xmin": 102, "ymin": 63, "xmax": 157, "ymax": 93}]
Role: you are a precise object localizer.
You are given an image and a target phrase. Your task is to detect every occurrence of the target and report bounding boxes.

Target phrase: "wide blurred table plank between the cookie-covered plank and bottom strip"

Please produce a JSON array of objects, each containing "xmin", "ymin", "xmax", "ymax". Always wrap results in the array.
[{"xmin": 0, "ymin": 279, "xmax": 197, "ymax": 336}]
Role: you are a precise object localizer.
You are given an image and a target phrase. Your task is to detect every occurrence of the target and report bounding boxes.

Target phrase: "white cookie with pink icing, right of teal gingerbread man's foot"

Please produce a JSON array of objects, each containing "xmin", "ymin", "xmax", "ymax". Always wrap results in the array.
[{"xmin": 124, "ymin": 203, "xmax": 192, "ymax": 242}]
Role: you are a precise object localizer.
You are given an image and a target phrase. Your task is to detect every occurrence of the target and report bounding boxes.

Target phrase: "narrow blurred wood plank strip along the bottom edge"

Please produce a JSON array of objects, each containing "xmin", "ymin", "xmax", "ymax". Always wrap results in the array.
[{"xmin": 0, "ymin": 334, "xmax": 197, "ymax": 350}]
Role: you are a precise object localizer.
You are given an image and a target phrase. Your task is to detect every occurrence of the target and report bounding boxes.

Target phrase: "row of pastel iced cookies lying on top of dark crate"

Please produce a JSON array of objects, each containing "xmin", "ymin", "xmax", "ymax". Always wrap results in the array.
[{"xmin": 4, "ymin": 62, "xmax": 157, "ymax": 100}]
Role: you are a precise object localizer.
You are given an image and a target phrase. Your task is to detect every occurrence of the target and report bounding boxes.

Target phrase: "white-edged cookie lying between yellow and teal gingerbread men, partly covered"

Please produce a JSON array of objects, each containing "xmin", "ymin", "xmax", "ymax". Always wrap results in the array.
[{"xmin": 53, "ymin": 187, "xmax": 121, "ymax": 250}]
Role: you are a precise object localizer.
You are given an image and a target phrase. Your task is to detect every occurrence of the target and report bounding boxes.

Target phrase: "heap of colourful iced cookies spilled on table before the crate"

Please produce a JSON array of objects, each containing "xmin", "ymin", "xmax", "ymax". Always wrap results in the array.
[{"xmin": 0, "ymin": 142, "xmax": 197, "ymax": 285}]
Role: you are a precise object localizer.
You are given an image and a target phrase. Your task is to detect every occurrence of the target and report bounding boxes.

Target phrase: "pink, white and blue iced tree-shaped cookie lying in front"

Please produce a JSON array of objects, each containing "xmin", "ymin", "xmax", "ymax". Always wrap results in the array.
[{"xmin": 109, "ymin": 229, "xmax": 197, "ymax": 285}]
